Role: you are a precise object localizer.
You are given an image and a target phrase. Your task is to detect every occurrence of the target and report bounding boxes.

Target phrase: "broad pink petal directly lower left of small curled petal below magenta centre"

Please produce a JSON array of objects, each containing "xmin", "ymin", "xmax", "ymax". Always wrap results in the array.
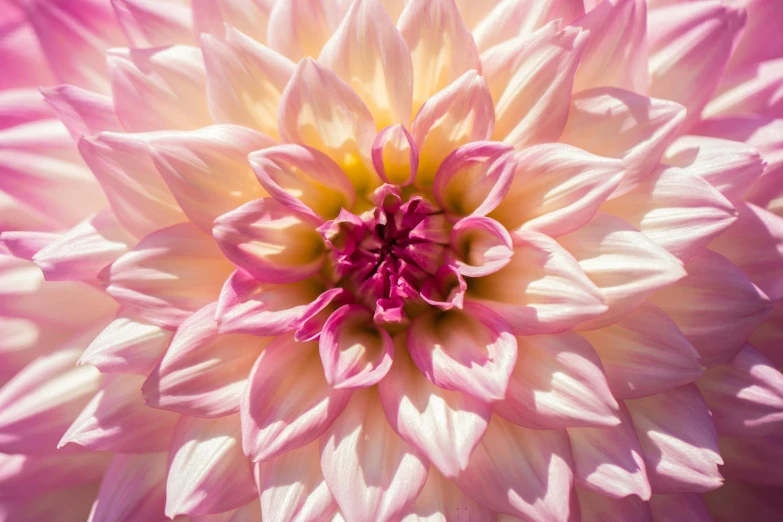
[{"xmin": 241, "ymin": 335, "xmax": 351, "ymax": 462}]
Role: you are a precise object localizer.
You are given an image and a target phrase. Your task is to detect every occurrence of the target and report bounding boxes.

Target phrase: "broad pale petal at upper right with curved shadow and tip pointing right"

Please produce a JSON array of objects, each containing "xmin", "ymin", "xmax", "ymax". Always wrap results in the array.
[{"xmin": 560, "ymin": 88, "xmax": 685, "ymax": 195}]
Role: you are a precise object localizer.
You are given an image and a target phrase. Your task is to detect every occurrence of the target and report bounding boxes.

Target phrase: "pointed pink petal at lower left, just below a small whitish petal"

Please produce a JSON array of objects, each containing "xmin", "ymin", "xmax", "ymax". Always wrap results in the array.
[{"xmin": 57, "ymin": 374, "xmax": 179, "ymax": 453}]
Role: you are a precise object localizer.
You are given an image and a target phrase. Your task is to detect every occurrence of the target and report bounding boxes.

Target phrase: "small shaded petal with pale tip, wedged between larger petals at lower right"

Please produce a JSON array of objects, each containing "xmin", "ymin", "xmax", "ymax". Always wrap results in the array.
[{"xmin": 568, "ymin": 406, "xmax": 650, "ymax": 500}]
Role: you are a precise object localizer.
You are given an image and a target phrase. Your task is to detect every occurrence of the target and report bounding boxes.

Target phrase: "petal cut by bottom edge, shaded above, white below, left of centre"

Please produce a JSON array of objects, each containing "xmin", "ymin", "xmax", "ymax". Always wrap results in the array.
[{"xmin": 254, "ymin": 442, "xmax": 337, "ymax": 522}]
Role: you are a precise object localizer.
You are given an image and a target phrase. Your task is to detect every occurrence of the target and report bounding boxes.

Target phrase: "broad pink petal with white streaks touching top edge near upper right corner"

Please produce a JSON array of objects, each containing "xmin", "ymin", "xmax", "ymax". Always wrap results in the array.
[{"xmin": 648, "ymin": 2, "xmax": 746, "ymax": 127}]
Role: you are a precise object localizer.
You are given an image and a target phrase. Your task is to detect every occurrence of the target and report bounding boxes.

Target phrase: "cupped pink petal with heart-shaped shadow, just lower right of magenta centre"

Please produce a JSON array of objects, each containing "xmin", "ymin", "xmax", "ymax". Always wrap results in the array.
[{"xmin": 408, "ymin": 302, "xmax": 517, "ymax": 402}]
